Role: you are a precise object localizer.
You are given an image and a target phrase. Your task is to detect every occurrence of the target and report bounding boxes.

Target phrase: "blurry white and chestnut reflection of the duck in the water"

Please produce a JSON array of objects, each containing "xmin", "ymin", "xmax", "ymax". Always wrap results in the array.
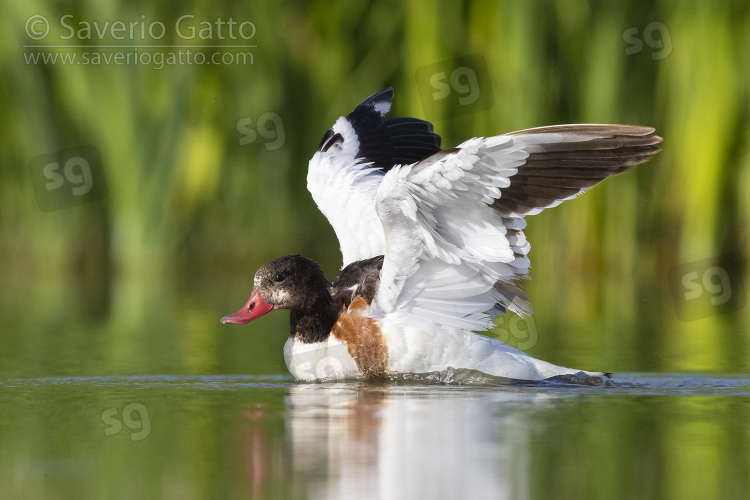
[{"xmin": 287, "ymin": 383, "xmax": 564, "ymax": 499}]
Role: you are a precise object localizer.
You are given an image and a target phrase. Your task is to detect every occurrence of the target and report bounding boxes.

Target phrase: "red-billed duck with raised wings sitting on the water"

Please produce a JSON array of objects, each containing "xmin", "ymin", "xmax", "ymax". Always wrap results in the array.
[{"xmin": 221, "ymin": 88, "xmax": 662, "ymax": 381}]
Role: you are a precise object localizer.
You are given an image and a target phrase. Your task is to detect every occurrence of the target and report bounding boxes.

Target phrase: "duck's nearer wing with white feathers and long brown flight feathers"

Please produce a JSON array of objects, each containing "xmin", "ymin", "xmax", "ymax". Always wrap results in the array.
[{"xmin": 373, "ymin": 125, "xmax": 661, "ymax": 330}]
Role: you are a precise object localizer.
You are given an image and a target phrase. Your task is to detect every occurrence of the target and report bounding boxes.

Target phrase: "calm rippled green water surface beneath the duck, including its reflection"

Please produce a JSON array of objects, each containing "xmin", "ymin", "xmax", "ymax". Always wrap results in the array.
[{"xmin": 0, "ymin": 371, "xmax": 750, "ymax": 499}]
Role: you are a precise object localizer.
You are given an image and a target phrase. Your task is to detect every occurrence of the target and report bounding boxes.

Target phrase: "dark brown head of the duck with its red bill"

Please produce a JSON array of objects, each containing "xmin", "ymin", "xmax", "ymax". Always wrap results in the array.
[{"xmin": 221, "ymin": 255, "xmax": 331, "ymax": 323}]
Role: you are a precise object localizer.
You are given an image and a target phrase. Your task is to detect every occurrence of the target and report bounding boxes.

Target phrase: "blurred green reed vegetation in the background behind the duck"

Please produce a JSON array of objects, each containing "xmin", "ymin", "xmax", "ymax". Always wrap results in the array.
[{"xmin": 0, "ymin": 0, "xmax": 750, "ymax": 375}]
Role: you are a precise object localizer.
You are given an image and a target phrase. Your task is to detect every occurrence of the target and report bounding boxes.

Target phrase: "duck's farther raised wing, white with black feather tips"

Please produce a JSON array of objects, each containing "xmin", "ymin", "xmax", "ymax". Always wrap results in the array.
[{"xmin": 307, "ymin": 88, "xmax": 440, "ymax": 266}]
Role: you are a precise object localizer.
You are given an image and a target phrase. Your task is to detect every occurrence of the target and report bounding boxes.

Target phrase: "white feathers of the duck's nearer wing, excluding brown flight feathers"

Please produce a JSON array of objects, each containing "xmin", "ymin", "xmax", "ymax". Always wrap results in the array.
[{"xmin": 373, "ymin": 136, "xmax": 529, "ymax": 330}]
